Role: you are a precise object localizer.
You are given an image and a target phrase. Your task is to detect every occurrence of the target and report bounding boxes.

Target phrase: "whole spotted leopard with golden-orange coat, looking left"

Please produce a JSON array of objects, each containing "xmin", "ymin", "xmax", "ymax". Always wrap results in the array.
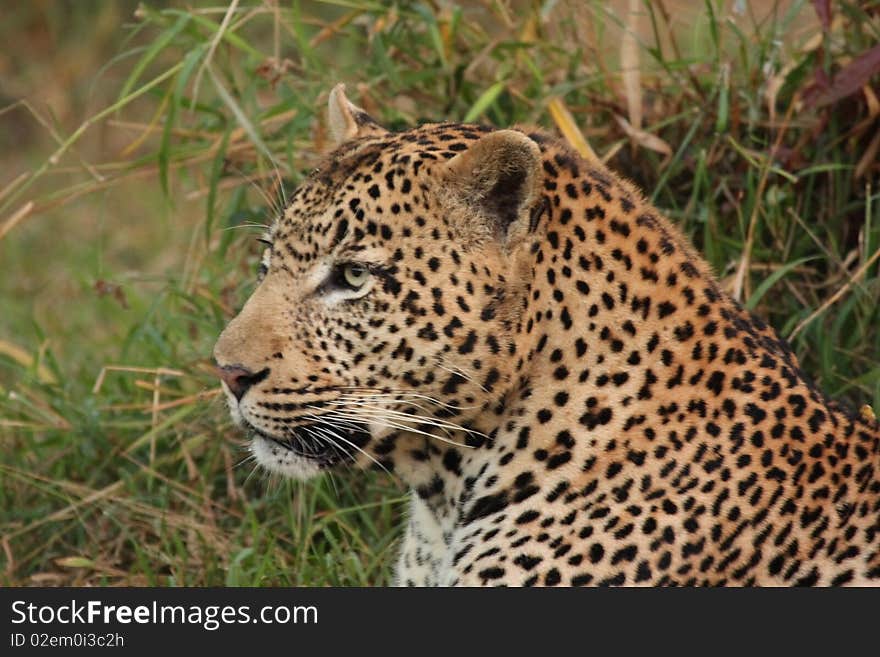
[{"xmin": 213, "ymin": 85, "xmax": 880, "ymax": 586}]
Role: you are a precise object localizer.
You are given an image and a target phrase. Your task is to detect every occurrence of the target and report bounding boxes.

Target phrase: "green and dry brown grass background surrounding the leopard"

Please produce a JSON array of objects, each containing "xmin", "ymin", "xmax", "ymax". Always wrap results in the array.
[{"xmin": 0, "ymin": 0, "xmax": 880, "ymax": 586}]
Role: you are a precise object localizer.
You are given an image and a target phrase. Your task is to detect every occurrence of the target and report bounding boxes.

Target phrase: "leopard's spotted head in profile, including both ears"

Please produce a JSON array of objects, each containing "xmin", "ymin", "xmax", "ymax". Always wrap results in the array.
[{"xmin": 214, "ymin": 86, "xmax": 541, "ymax": 478}]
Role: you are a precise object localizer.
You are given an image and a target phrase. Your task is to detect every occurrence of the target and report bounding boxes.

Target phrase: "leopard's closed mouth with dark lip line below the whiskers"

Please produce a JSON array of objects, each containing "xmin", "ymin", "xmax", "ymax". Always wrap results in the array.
[{"xmin": 244, "ymin": 421, "xmax": 370, "ymax": 469}]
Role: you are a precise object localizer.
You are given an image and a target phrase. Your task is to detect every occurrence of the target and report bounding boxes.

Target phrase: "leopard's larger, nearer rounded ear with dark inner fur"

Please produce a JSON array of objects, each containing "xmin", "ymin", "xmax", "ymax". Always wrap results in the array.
[{"xmin": 446, "ymin": 130, "xmax": 542, "ymax": 247}]
